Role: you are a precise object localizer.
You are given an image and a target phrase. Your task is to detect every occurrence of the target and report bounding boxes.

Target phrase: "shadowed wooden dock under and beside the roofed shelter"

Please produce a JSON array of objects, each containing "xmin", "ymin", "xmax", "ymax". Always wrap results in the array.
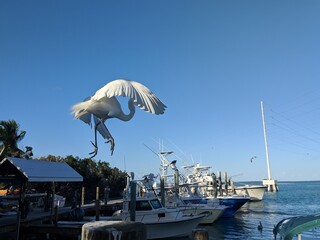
[{"xmin": 0, "ymin": 200, "xmax": 122, "ymax": 240}]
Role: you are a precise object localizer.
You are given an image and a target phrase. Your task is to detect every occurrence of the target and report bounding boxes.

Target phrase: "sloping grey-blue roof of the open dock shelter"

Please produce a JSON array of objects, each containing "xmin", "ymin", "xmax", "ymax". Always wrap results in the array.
[{"xmin": 0, "ymin": 157, "xmax": 83, "ymax": 182}]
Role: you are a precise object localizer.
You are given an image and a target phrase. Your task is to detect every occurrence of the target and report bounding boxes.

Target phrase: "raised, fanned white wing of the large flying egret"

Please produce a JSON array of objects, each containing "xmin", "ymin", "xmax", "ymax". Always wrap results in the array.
[{"xmin": 92, "ymin": 79, "xmax": 166, "ymax": 114}]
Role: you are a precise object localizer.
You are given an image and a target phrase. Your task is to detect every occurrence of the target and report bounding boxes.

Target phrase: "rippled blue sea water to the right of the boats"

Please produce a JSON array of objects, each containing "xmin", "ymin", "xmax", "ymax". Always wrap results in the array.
[{"xmin": 194, "ymin": 181, "xmax": 320, "ymax": 240}]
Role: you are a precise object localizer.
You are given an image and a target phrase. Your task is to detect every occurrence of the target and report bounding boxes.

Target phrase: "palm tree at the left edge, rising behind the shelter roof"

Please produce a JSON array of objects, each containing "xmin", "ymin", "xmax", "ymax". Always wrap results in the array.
[{"xmin": 0, "ymin": 120, "xmax": 30, "ymax": 160}]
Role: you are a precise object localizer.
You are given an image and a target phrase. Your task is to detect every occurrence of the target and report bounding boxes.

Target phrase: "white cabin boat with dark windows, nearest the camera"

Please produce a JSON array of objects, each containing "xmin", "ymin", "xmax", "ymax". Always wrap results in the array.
[{"xmin": 111, "ymin": 197, "xmax": 205, "ymax": 239}]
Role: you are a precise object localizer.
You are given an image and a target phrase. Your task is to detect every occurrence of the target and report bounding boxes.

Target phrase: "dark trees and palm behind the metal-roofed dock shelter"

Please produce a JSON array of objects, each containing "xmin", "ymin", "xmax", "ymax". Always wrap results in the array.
[{"xmin": 0, "ymin": 120, "xmax": 126, "ymax": 200}]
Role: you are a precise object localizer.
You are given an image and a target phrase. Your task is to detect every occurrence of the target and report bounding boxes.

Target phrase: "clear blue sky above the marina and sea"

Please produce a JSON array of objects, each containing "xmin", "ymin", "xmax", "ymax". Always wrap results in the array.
[{"xmin": 0, "ymin": 0, "xmax": 320, "ymax": 181}]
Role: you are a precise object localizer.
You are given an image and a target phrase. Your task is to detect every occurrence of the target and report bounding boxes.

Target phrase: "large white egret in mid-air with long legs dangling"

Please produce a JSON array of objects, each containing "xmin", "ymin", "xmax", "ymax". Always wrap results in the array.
[{"xmin": 72, "ymin": 79, "xmax": 166, "ymax": 157}]
